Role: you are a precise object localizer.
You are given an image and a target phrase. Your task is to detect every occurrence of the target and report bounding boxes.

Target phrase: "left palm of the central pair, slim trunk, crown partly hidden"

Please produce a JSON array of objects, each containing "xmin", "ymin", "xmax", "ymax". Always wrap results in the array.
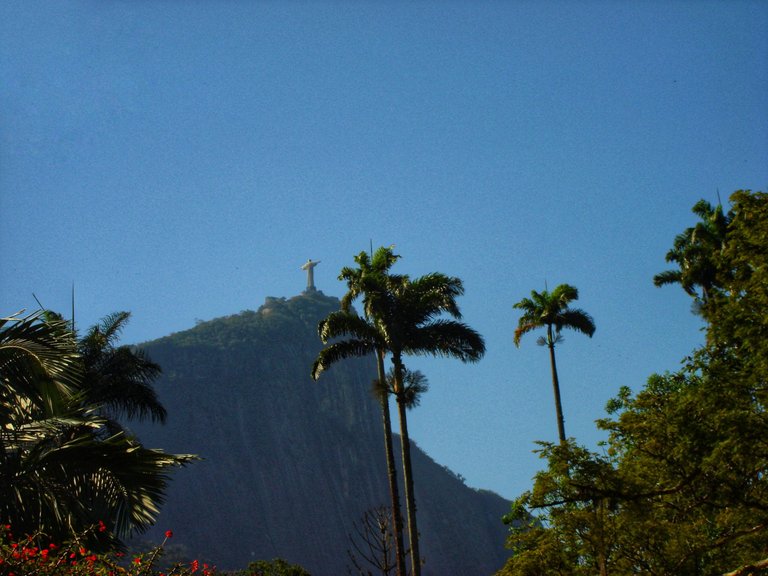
[{"xmin": 312, "ymin": 251, "xmax": 407, "ymax": 576}]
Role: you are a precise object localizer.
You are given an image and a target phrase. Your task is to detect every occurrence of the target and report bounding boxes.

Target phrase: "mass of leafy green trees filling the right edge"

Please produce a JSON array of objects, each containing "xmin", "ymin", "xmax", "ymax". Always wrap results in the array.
[{"xmin": 499, "ymin": 191, "xmax": 768, "ymax": 576}]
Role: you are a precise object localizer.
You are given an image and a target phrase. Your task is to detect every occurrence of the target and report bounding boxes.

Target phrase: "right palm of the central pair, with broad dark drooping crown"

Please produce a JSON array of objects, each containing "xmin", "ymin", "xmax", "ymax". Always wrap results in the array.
[{"xmin": 318, "ymin": 247, "xmax": 485, "ymax": 576}]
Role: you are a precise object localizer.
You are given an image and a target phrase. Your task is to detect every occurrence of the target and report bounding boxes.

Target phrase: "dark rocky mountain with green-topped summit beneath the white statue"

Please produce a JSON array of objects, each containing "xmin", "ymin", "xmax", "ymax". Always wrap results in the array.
[{"xmin": 136, "ymin": 292, "xmax": 509, "ymax": 576}]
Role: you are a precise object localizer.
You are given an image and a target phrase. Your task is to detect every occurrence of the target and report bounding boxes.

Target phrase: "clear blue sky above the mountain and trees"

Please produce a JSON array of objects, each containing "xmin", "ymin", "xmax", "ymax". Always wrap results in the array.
[{"xmin": 0, "ymin": 0, "xmax": 768, "ymax": 497}]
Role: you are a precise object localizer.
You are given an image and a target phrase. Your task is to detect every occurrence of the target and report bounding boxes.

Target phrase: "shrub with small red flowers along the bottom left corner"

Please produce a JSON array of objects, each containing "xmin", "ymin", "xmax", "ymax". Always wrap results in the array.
[{"xmin": 0, "ymin": 522, "xmax": 216, "ymax": 576}]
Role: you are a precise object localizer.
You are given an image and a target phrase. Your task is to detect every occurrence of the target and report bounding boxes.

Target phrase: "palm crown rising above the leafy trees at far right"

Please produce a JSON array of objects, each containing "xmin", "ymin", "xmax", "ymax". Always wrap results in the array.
[{"xmin": 653, "ymin": 200, "xmax": 733, "ymax": 309}]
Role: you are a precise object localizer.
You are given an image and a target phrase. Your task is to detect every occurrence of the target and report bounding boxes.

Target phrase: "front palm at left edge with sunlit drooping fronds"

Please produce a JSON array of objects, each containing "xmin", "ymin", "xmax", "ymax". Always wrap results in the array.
[{"xmin": 0, "ymin": 312, "xmax": 193, "ymax": 541}]
